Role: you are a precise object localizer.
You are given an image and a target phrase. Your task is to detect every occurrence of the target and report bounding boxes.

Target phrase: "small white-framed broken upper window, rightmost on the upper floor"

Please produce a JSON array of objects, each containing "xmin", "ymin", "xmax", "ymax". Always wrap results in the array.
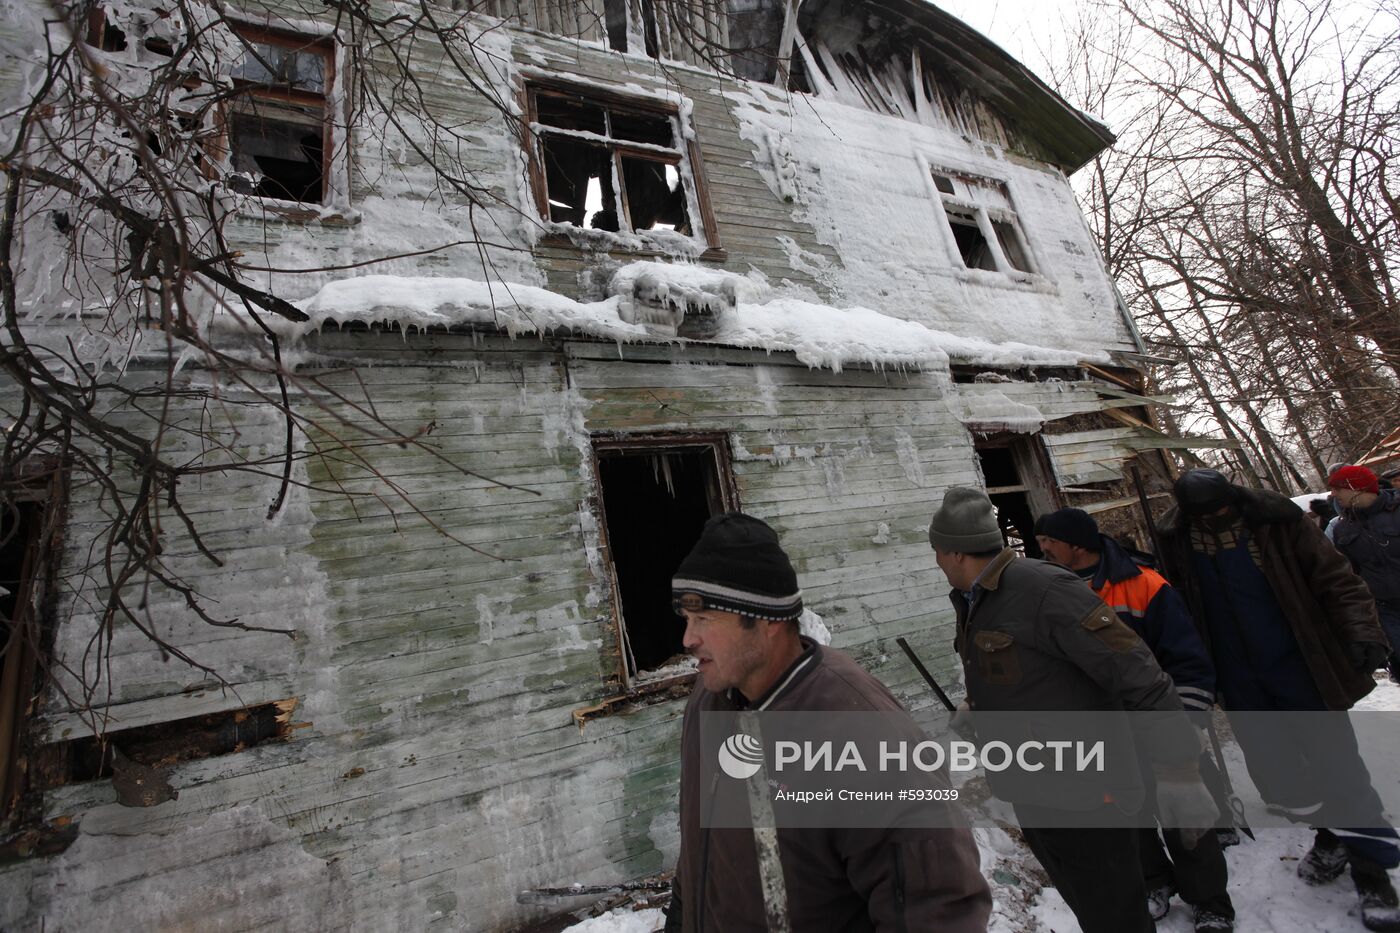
[{"xmin": 934, "ymin": 171, "xmax": 1036, "ymax": 273}]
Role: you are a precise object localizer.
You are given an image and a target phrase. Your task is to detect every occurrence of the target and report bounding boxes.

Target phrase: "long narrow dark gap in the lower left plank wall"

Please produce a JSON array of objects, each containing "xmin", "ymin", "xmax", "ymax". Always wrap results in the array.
[{"xmin": 38, "ymin": 699, "xmax": 297, "ymax": 787}]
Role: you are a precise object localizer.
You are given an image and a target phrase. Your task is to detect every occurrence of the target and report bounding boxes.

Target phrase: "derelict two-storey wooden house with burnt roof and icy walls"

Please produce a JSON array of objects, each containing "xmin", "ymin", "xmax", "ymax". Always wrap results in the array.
[{"xmin": 0, "ymin": 0, "xmax": 1215, "ymax": 930}]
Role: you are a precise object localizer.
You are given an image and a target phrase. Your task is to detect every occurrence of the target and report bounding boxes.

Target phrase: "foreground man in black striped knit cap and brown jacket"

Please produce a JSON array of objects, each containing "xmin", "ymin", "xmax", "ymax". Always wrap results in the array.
[{"xmin": 666, "ymin": 513, "xmax": 991, "ymax": 933}]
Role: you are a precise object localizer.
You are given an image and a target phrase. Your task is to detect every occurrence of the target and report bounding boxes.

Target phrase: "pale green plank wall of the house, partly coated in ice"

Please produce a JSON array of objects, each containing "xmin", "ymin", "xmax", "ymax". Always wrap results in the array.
[{"xmin": 0, "ymin": 4, "xmax": 1127, "ymax": 930}]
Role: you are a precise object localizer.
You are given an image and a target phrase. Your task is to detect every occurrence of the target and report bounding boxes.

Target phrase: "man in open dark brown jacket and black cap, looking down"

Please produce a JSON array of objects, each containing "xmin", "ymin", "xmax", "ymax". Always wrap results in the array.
[{"xmin": 1158, "ymin": 469, "xmax": 1400, "ymax": 930}]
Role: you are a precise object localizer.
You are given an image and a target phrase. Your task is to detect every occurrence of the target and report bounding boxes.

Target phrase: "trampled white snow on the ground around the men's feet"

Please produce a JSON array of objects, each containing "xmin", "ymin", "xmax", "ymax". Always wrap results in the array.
[{"xmin": 564, "ymin": 679, "xmax": 1400, "ymax": 933}]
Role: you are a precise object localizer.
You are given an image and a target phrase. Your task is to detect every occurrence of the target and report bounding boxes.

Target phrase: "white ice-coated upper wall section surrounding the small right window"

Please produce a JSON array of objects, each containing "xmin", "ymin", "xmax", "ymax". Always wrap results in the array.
[{"xmin": 727, "ymin": 84, "xmax": 1135, "ymax": 356}]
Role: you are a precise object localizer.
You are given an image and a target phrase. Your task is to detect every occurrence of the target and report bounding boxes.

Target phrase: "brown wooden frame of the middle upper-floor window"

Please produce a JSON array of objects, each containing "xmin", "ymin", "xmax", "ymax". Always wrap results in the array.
[{"xmin": 521, "ymin": 76, "xmax": 725, "ymax": 259}]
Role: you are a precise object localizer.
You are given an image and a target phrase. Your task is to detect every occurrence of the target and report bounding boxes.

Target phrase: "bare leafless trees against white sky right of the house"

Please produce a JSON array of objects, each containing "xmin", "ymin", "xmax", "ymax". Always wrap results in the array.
[{"xmin": 1058, "ymin": 0, "xmax": 1400, "ymax": 488}]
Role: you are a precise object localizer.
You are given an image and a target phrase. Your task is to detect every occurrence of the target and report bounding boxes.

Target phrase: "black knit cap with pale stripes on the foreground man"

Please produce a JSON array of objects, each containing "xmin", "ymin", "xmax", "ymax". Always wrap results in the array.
[{"xmin": 671, "ymin": 511, "xmax": 802, "ymax": 622}]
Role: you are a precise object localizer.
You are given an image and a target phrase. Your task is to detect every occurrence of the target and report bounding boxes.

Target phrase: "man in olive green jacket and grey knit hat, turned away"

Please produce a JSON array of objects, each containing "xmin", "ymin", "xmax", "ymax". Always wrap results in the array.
[{"xmin": 928, "ymin": 488, "xmax": 1217, "ymax": 933}]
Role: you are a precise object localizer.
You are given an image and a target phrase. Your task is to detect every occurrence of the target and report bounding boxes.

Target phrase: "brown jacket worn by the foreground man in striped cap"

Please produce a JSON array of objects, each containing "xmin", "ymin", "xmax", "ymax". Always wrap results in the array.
[{"xmin": 668, "ymin": 640, "xmax": 991, "ymax": 933}]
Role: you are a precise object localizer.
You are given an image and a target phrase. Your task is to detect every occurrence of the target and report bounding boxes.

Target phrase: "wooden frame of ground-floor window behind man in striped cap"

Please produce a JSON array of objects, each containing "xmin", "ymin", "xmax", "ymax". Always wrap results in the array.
[{"xmin": 591, "ymin": 431, "xmax": 739, "ymax": 698}]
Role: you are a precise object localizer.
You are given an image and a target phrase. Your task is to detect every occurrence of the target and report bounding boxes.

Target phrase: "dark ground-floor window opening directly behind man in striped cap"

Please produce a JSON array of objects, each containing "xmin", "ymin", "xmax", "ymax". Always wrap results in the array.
[{"xmin": 594, "ymin": 436, "xmax": 736, "ymax": 688}]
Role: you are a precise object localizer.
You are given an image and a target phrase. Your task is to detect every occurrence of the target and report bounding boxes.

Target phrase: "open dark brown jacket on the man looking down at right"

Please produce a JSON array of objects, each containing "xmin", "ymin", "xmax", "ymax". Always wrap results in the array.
[{"xmin": 1158, "ymin": 486, "xmax": 1386, "ymax": 710}]
